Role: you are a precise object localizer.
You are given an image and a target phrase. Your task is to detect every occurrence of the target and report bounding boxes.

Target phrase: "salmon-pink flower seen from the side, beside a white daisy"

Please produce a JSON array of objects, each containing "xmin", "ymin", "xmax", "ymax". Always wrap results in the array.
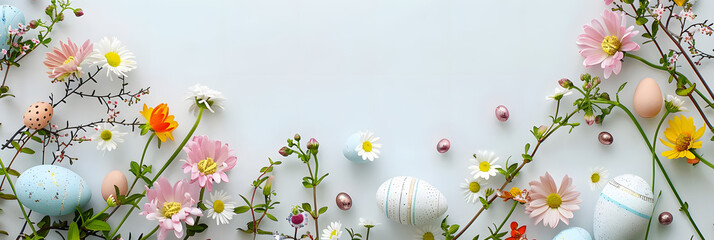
[{"xmin": 44, "ymin": 38, "xmax": 93, "ymax": 82}]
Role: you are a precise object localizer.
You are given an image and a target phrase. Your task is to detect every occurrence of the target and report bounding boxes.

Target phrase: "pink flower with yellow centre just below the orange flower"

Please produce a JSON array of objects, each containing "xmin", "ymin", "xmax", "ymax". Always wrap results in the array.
[{"xmin": 181, "ymin": 136, "xmax": 238, "ymax": 191}]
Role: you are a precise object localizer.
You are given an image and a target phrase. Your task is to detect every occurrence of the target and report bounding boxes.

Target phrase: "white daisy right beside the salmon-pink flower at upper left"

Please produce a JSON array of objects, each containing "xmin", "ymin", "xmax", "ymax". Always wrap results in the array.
[{"xmin": 87, "ymin": 37, "xmax": 136, "ymax": 80}]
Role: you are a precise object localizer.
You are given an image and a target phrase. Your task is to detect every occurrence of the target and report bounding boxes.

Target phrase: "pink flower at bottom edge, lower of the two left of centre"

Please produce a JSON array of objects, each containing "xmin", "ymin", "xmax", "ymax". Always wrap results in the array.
[{"xmin": 139, "ymin": 177, "xmax": 203, "ymax": 240}]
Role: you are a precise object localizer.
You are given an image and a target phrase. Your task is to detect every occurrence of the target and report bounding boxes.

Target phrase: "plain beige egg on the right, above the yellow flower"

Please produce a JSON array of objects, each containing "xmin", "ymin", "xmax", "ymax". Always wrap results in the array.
[{"xmin": 632, "ymin": 78, "xmax": 663, "ymax": 118}]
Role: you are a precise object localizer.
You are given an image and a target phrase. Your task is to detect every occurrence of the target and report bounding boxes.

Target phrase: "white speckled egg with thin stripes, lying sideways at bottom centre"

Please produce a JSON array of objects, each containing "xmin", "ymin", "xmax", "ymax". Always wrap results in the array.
[{"xmin": 376, "ymin": 176, "xmax": 449, "ymax": 225}]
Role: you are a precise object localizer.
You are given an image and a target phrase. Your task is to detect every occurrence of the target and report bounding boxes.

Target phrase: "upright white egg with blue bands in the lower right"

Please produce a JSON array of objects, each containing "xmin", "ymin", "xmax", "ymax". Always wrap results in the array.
[{"xmin": 593, "ymin": 174, "xmax": 654, "ymax": 240}]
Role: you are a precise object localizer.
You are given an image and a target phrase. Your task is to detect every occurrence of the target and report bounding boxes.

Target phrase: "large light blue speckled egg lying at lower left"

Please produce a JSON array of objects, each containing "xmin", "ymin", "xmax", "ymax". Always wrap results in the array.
[{"xmin": 15, "ymin": 165, "xmax": 92, "ymax": 216}]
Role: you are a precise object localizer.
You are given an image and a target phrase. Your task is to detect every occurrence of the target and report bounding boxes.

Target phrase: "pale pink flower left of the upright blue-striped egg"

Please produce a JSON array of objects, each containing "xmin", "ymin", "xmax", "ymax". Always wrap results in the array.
[{"xmin": 526, "ymin": 172, "xmax": 582, "ymax": 228}]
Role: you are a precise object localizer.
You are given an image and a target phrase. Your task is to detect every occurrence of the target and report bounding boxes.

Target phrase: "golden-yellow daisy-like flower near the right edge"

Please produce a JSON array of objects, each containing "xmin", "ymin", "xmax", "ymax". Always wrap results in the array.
[{"xmin": 659, "ymin": 115, "xmax": 704, "ymax": 159}]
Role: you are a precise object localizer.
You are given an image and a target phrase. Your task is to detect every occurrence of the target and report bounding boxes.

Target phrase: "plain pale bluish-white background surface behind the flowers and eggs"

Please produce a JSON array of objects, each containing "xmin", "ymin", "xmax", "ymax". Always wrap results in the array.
[{"xmin": 0, "ymin": 0, "xmax": 714, "ymax": 239}]
